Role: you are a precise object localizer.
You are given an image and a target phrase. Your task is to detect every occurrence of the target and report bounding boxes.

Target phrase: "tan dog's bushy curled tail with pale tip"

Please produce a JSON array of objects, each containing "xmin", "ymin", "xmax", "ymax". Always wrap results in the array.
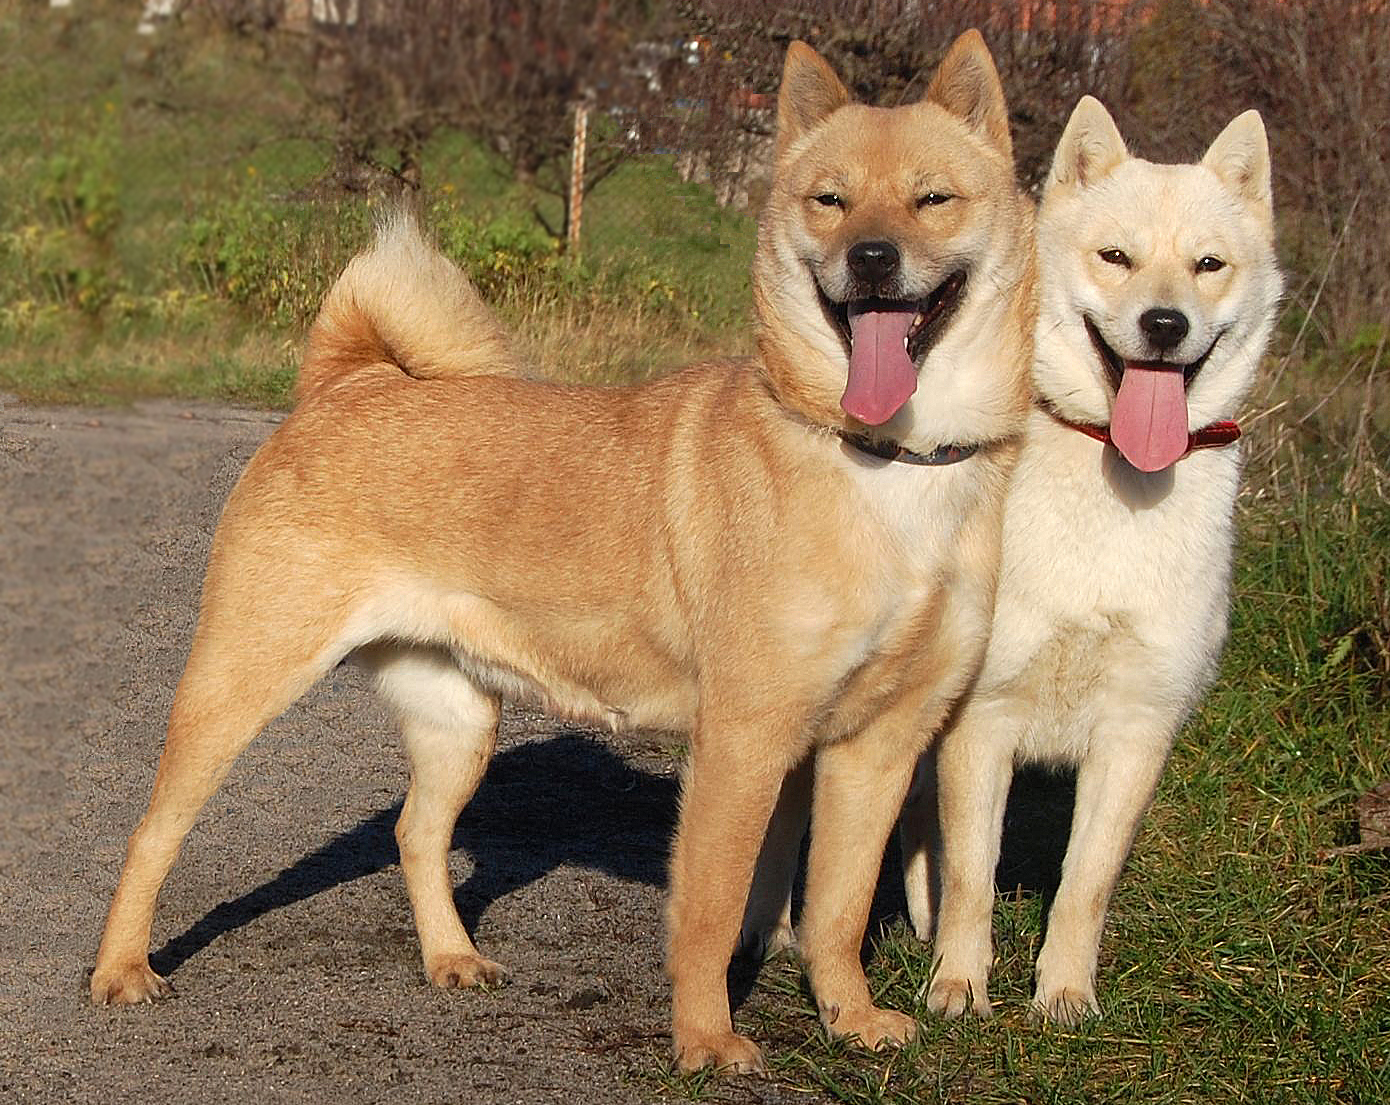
[{"xmin": 295, "ymin": 208, "xmax": 520, "ymax": 399}]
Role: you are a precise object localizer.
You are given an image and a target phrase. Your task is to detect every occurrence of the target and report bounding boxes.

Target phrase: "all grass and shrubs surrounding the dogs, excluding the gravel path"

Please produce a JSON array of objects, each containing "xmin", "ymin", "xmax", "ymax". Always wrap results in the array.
[{"xmin": 0, "ymin": 0, "xmax": 1390, "ymax": 1102}]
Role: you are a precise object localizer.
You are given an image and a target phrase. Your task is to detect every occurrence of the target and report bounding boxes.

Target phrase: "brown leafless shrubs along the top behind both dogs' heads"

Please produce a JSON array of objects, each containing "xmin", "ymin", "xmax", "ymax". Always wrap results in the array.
[{"xmin": 182, "ymin": 0, "xmax": 1390, "ymax": 425}]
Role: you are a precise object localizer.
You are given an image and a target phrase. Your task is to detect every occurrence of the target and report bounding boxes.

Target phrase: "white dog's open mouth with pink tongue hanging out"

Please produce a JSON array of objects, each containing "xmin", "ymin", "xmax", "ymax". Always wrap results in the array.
[{"xmin": 1081, "ymin": 314, "xmax": 1220, "ymax": 473}]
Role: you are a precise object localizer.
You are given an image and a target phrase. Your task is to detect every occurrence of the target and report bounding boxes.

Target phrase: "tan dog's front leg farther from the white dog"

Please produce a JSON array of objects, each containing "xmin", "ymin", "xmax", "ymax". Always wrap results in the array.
[{"xmin": 667, "ymin": 720, "xmax": 799, "ymax": 1073}]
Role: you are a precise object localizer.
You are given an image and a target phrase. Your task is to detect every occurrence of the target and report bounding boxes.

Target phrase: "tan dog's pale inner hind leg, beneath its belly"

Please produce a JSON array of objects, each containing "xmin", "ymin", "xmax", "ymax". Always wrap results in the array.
[{"xmin": 359, "ymin": 645, "xmax": 506, "ymax": 987}]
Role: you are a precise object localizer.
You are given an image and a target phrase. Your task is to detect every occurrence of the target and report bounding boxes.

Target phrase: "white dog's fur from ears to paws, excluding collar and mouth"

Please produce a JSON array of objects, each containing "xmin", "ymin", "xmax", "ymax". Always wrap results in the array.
[{"xmin": 904, "ymin": 97, "xmax": 1280, "ymax": 1022}]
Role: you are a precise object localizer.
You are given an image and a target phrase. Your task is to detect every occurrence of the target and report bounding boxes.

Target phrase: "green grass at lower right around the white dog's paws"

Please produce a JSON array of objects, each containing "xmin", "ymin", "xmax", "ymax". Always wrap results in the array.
[{"xmin": 644, "ymin": 496, "xmax": 1390, "ymax": 1105}]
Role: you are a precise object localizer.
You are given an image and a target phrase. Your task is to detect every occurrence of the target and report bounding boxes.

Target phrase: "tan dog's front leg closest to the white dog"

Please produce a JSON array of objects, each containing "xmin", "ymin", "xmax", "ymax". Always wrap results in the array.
[{"xmin": 796, "ymin": 719, "xmax": 920, "ymax": 1049}]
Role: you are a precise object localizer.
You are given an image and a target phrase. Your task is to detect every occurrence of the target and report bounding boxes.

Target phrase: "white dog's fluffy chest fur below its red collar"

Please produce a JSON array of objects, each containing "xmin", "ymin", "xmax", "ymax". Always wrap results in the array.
[{"xmin": 979, "ymin": 413, "xmax": 1240, "ymax": 762}]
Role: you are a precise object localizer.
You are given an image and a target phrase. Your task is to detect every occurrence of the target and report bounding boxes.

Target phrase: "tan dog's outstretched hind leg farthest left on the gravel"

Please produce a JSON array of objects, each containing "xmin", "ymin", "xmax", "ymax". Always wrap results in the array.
[{"xmin": 92, "ymin": 592, "xmax": 346, "ymax": 1005}]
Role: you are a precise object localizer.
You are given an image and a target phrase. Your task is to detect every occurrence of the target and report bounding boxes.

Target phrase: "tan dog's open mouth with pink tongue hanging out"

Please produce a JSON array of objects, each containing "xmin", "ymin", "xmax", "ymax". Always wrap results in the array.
[{"xmin": 816, "ymin": 270, "xmax": 966, "ymax": 425}]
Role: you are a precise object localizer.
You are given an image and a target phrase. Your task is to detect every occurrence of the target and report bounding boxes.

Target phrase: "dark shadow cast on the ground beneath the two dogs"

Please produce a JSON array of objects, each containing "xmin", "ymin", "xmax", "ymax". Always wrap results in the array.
[{"xmin": 150, "ymin": 728, "xmax": 1073, "ymax": 1008}]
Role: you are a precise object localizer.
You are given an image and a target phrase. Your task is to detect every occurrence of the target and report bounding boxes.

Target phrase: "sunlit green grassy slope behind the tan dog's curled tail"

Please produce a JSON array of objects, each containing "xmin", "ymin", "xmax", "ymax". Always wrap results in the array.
[{"xmin": 0, "ymin": 3, "xmax": 753, "ymax": 406}]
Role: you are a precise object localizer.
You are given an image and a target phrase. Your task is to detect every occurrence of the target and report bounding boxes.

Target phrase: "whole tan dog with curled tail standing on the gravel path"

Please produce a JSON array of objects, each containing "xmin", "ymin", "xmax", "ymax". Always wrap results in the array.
[{"xmin": 92, "ymin": 33, "xmax": 1031, "ymax": 1070}]
